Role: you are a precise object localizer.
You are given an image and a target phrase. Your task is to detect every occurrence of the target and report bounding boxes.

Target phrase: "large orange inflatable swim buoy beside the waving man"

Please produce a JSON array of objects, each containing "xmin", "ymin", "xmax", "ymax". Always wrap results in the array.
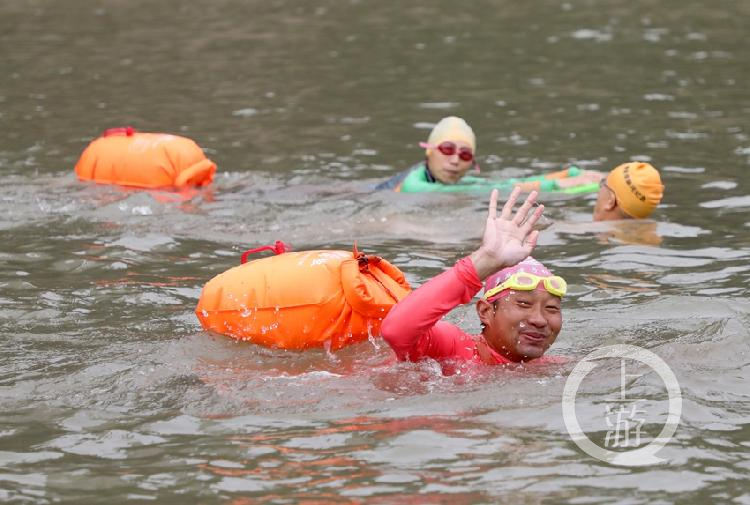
[{"xmin": 195, "ymin": 242, "xmax": 411, "ymax": 350}]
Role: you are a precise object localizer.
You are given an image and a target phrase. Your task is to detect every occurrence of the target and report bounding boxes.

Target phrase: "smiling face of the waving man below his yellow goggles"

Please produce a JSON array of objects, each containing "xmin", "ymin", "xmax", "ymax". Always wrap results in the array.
[{"xmin": 477, "ymin": 289, "xmax": 562, "ymax": 362}]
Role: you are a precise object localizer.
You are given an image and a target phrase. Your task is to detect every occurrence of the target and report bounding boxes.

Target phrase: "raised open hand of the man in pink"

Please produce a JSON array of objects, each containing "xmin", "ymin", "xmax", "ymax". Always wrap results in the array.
[{"xmin": 470, "ymin": 187, "xmax": 544, "ymax": 280}]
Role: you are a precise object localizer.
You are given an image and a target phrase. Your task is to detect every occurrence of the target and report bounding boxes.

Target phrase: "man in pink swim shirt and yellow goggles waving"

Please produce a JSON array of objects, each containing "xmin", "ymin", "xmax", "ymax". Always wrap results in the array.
[{"xmin": 381, "ymin": 188, "xmax": 567, "ymax": 365}]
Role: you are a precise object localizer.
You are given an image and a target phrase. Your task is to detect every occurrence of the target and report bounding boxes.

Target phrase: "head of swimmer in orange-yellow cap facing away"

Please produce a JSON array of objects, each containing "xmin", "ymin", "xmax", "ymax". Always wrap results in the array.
[{"xmin": 594, "ymin": 161, "xmax": 664, "ymax": 221}]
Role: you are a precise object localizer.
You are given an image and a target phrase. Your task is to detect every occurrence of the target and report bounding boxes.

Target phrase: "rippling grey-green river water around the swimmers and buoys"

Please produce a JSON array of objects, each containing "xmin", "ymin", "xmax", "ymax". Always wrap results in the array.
[{"xmin": 0, "ymin": 0, "xmax": 750, "ymax": 504}]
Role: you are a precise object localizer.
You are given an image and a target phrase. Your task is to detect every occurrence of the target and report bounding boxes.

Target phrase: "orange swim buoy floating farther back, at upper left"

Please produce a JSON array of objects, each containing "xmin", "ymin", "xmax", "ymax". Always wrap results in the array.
[{"xmin": 75, "ymin": 127, "xmax": 216, "ymax": 189}]
